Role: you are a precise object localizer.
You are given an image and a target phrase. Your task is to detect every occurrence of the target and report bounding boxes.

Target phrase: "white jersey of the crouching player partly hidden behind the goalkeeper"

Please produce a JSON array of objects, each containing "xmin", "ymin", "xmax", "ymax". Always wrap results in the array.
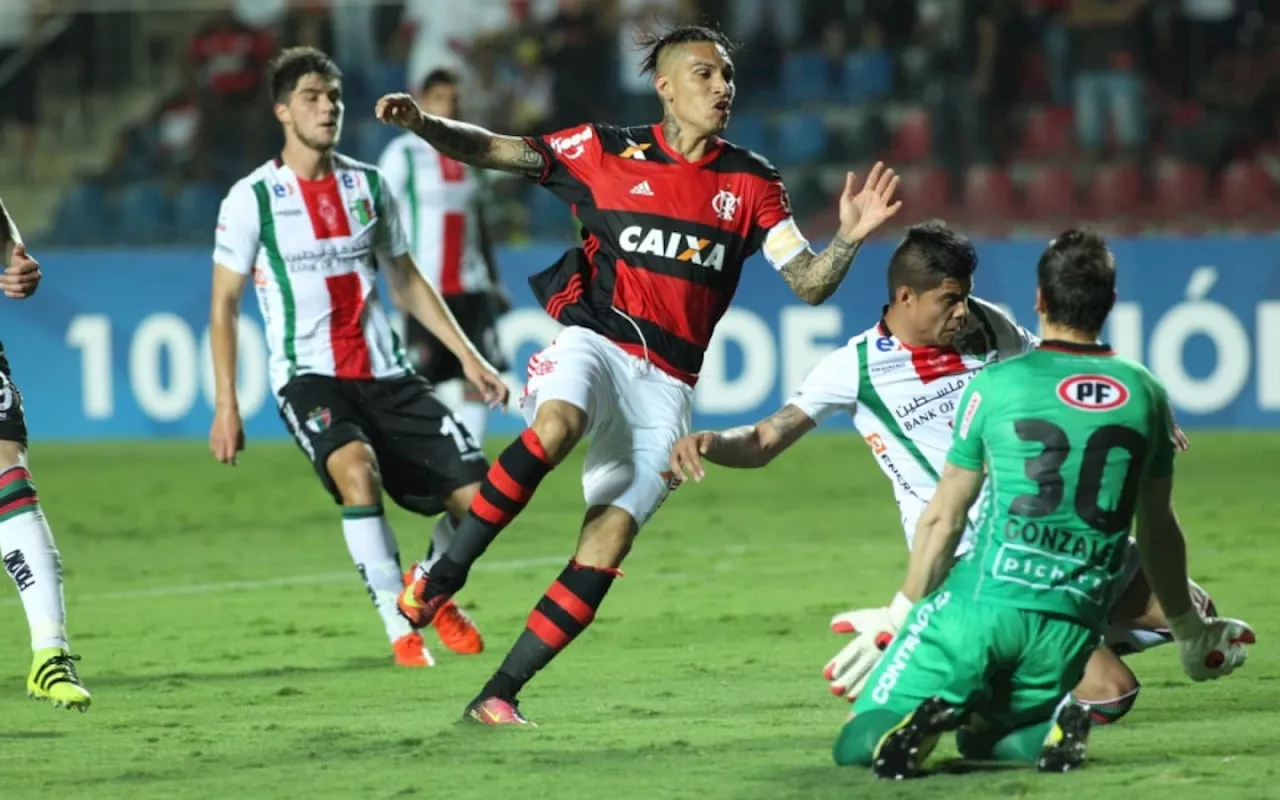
[{"xmin": 787, "ymin": 297, "xmax": 1037, "ymax": 552}]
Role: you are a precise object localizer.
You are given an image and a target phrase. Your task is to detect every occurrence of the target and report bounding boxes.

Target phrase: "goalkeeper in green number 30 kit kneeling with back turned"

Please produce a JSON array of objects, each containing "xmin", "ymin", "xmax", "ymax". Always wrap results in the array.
[{"xmin": 833, "ymin": 230, "xmax": 1254, "ymax": 778}]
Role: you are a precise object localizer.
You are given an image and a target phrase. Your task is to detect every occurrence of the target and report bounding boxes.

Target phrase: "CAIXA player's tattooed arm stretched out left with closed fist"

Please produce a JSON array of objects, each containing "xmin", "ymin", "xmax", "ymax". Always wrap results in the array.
[{"xmin": 375, "ymin": 93, "xmax": 547, "ymax": 175}]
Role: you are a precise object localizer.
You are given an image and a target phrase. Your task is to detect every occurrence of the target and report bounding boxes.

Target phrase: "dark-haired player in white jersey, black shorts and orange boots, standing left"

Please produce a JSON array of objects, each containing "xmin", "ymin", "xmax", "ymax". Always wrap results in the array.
[{"xmin": 210, "ymin": 47, "xmax": 507, "ymax": 667}]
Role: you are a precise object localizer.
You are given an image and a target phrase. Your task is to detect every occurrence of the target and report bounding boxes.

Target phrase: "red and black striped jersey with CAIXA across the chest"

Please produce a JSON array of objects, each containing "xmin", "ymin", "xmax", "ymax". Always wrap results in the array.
[{"xmin": 525, "ymin": 124, "xmax": 808, "ymax": 385}]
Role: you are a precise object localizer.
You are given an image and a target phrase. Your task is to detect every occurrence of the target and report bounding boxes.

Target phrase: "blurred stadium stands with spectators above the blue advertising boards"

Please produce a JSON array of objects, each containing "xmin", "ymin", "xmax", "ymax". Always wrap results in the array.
[{"xmin": 0, "ymin": 0, "xmax": 1280, "ymax": 244}]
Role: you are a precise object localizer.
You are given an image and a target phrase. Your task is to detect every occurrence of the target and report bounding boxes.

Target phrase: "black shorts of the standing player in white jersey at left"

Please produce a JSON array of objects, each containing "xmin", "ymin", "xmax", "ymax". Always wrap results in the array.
[{"xmin": 279, "ymin": 375, "xmax": 489, "ymax": 516}]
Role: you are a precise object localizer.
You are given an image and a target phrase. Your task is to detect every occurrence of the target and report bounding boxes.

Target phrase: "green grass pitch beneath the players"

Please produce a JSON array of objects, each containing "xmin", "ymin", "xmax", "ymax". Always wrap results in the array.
[{"xmin": 0, "ymin": 433, "xmax": 1280, "ymax": 800}]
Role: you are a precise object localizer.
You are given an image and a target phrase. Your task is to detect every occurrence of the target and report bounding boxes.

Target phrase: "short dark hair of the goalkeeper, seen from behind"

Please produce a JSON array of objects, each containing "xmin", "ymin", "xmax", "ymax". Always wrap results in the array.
[{"xmin": 1036, "ymin": 228, "xmax": 1116, "ymax": 334}]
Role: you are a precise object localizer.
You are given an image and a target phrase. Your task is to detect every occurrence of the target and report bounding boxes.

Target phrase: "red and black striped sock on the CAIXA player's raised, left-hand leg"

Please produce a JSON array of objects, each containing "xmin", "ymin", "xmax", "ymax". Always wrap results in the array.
[{"xmin": 426, "ymin": 428, "xmax": 556, "ymax": 596}]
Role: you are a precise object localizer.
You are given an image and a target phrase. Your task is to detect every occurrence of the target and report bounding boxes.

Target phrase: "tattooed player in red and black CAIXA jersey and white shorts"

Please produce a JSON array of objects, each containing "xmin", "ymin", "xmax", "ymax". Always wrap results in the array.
[{"xmin": 376, "ymin": 27, "xmax": 901, "ymax": 724}]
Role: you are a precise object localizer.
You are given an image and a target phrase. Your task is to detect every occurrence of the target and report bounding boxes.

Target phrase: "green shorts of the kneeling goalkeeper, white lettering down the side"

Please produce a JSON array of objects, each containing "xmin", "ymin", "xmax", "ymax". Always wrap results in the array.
[{"xmin": 854, "ymin": 589, "xmax": 1101, "ymax": 731}]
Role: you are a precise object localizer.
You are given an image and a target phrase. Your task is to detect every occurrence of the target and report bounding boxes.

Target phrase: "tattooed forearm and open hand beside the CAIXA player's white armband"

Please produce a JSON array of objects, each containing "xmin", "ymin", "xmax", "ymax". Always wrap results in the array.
[{"xmin": 764, "ymin": 161, "xmax": 902, "ymax": 306}]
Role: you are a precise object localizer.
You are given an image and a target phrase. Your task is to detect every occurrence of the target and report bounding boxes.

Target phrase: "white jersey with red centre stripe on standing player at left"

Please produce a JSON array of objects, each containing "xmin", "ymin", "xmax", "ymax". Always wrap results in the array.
[{"xmin": 214, "ymin": 155, "xmax": 412, "ymax": 392}]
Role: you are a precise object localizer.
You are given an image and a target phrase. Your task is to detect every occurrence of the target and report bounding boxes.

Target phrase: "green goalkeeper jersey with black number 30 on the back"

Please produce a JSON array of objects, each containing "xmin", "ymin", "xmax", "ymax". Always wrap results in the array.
[{"xmin": 945, "ymin": 342, "xmax": 1174, "ymax": 628}]
